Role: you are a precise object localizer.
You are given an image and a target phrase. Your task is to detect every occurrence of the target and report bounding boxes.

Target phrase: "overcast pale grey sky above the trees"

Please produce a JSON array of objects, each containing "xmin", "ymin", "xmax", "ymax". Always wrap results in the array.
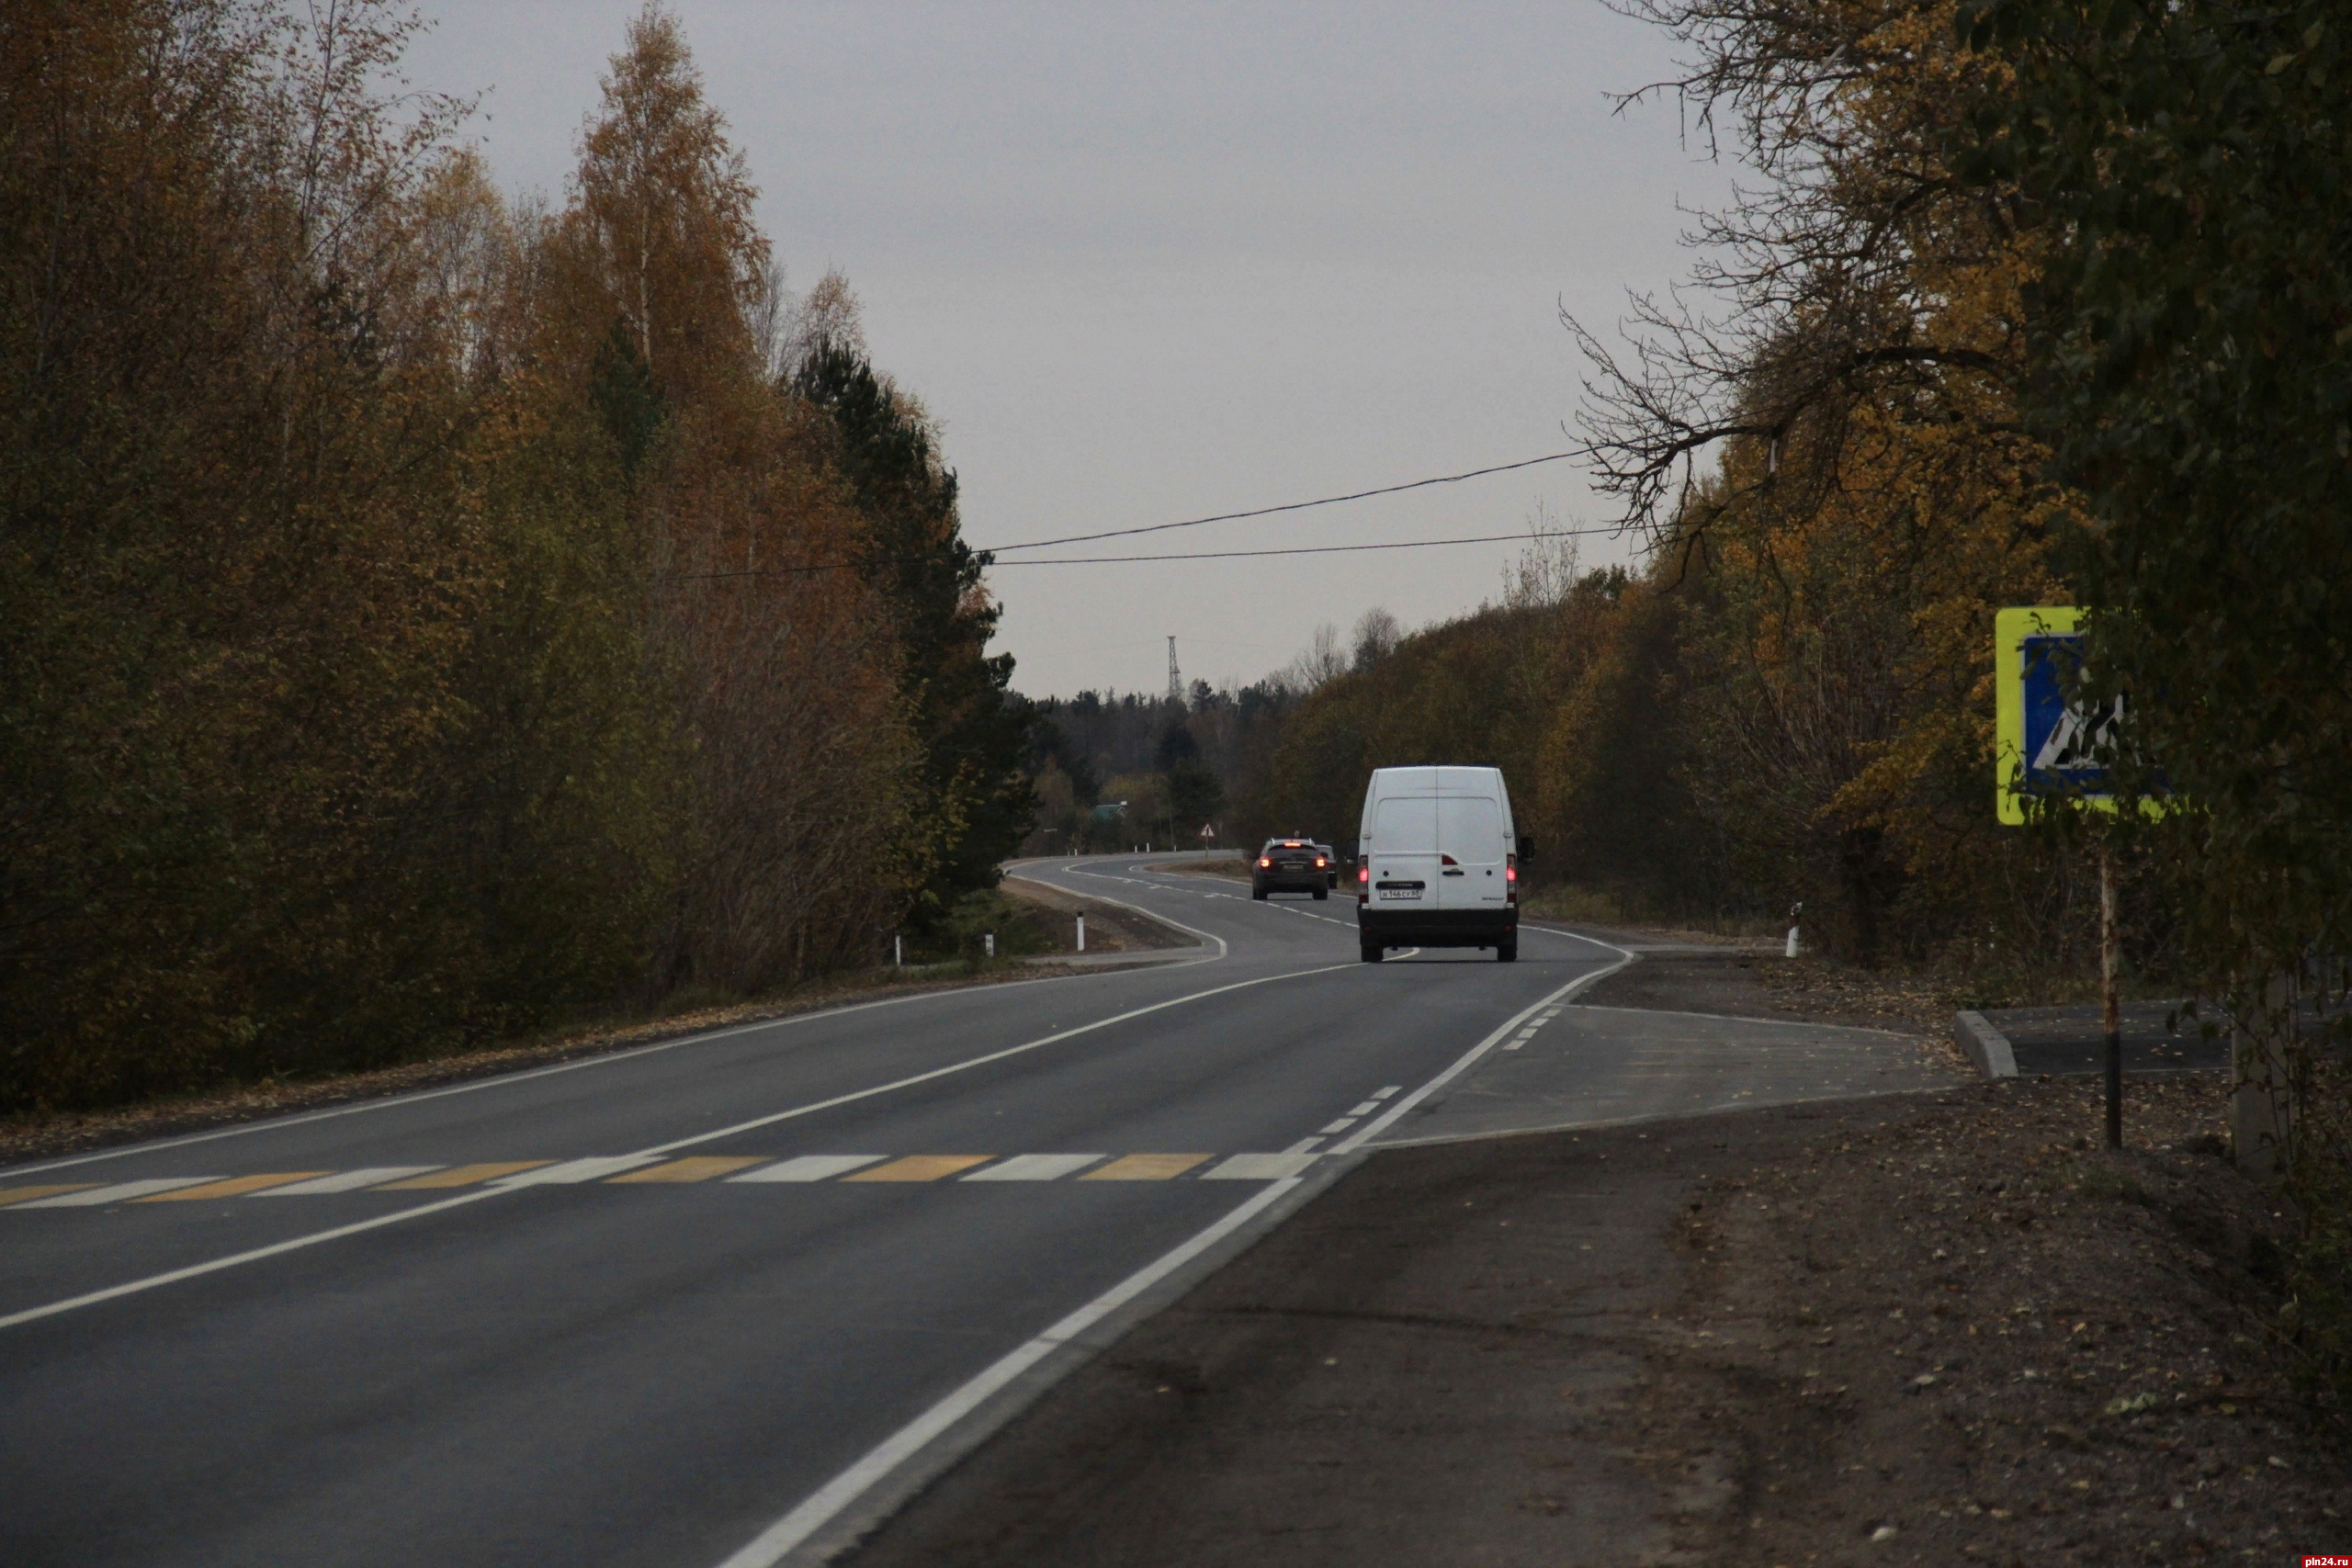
[{"xmin": 409, "ymin": 0, "xmax": 1726, "ymax": 696}]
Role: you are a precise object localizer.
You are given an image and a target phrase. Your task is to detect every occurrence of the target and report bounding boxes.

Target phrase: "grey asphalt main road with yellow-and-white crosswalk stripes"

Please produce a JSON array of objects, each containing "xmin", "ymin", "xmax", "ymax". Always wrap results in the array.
[{"xmin": 0, "ymin": 858, "xmax": 1938, "ymax": 1568}]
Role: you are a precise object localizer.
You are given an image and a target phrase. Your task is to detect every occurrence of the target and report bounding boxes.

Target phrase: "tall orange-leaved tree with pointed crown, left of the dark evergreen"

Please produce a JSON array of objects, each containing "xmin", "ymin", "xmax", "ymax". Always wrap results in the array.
[{"xmin": 548, "ymin": 7, "xmax": 922, "ymax": 987}]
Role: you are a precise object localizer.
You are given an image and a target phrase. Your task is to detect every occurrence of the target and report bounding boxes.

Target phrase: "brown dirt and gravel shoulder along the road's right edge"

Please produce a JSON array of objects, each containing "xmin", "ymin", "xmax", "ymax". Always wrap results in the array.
[{"xmin": 854, "ymin": 962, "xmax": 2352, "ymax": 1568}]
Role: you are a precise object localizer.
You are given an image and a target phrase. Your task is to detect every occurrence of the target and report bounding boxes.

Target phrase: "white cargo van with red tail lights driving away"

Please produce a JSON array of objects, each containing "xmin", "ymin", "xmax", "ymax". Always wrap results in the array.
[{"xmin": 1355, "ymin": 766, "xmax": 1533, "ymax": 964}]
